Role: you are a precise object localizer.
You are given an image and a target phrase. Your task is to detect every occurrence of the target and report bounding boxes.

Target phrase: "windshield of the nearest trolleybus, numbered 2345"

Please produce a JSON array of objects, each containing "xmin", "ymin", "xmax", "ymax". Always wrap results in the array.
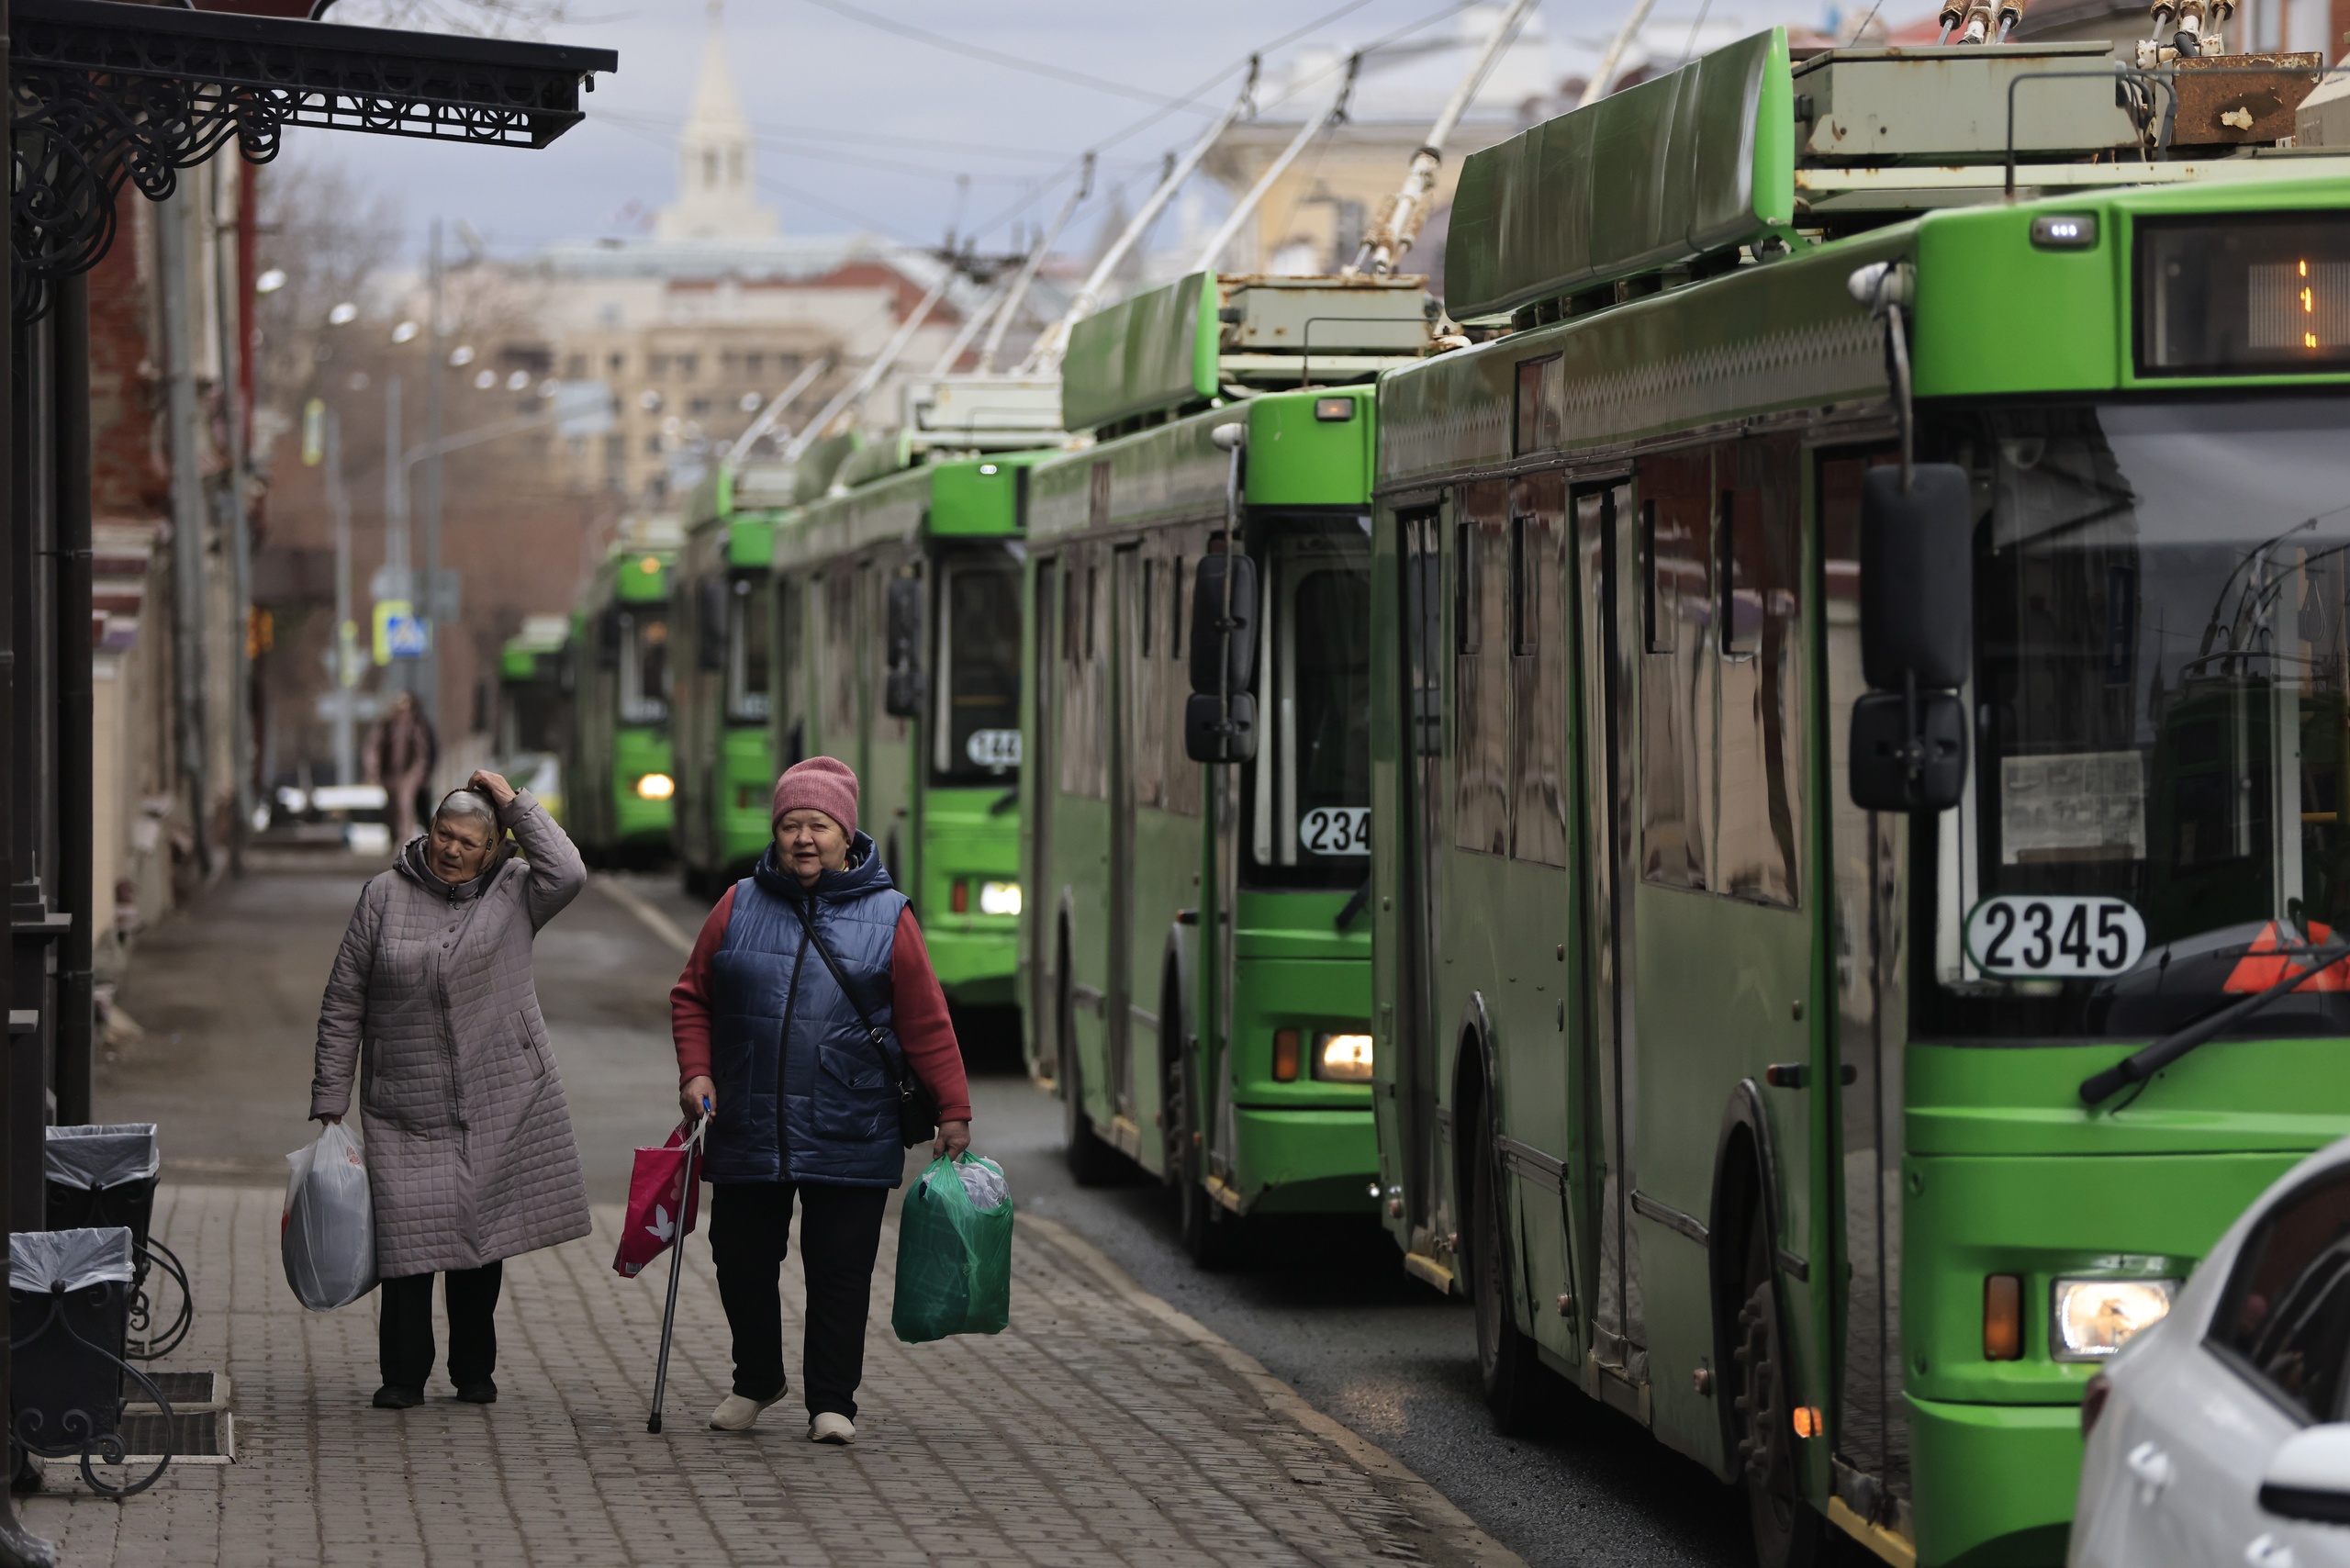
[{"xmin": 1915, "ymin": 398, "xmax": 2350, "ymax": 1036}]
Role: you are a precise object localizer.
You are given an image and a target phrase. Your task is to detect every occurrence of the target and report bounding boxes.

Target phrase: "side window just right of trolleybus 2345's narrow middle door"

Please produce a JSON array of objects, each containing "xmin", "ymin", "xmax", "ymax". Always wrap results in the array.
[{"xmin": 1640, "ymin": 452, "xmax": 1716, "ymax": 889}]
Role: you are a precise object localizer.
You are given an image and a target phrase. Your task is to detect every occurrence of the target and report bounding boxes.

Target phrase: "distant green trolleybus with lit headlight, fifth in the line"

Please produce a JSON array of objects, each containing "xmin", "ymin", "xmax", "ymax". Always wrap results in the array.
[{"xmin": 564, "ymin": 517, "xmax": 677, "ymax": 865}]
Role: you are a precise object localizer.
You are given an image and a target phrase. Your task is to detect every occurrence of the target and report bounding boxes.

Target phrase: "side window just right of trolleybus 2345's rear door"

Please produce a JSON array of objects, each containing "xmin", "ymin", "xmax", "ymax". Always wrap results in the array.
[{"xmin": 1452, "ymin": 479, "xmax": 1509, "ymax": 856}]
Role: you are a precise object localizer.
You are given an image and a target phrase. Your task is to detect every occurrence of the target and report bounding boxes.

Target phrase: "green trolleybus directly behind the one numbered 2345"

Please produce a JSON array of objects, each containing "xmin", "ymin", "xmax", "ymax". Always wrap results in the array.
[{"xmin": 1023, "ymin": 273, "xmax": 1428, "ymax": 1262}]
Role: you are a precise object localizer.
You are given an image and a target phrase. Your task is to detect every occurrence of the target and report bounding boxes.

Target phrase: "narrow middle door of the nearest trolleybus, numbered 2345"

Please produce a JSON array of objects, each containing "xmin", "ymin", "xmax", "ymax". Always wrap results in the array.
[{"xmin": 1574, "ymin": 485, "xmax": 1648, "ymax": 1372}]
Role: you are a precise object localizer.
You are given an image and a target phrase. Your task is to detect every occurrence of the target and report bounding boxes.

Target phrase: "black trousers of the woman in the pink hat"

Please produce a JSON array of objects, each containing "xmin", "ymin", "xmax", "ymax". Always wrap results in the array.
[{"xmin": 710, "ymin": 1182, "xmax": 889, "ymax": 1420}]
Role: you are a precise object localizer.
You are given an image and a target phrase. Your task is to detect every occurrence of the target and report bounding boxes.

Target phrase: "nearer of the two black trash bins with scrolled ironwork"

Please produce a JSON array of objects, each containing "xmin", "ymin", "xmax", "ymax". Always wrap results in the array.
[{"xmin": 7, "ymin": 1225, "xmax": 172, "ymax": 1497}]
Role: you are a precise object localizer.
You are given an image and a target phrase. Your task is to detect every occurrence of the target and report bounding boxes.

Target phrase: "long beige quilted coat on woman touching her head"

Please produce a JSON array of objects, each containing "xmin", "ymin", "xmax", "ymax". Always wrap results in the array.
[{"xmin": 310, "ymin": 790, "xmax": 588, "ymax": 1279}]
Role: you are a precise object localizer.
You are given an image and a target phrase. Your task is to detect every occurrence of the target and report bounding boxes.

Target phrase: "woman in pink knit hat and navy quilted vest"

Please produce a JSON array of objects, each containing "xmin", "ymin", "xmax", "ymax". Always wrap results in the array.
[{"xmin": 670, "ymin": 757, "xmax": 970, "ymax": 1443}]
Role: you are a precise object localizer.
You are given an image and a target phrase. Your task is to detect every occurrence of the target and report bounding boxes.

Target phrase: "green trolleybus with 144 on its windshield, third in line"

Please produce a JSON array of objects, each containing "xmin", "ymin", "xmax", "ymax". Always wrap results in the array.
[{"xmin": 761, "ymin": 376, "xmax": 1062, "ymax": 1009}]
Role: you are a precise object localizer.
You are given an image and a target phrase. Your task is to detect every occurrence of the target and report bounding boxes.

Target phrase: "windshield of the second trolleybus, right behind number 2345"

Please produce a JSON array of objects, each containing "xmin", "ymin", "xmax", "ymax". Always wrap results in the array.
[{"xmin": 1241, "ymin": 517, "xmax": 1370, "ymax": 889}]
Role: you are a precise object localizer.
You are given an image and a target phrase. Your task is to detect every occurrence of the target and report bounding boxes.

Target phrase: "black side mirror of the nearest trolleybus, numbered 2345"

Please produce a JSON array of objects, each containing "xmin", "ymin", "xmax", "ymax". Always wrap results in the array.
[{"xmin": 1850, "ymin": 463, "xmax": 1974, "ymax": 811}]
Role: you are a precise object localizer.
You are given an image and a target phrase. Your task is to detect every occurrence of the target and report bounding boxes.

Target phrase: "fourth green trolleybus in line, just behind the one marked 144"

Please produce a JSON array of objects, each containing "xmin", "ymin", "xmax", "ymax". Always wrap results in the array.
[{"xmin": 670, "ymin": 463, "xmax": 792, "ymax": 898}]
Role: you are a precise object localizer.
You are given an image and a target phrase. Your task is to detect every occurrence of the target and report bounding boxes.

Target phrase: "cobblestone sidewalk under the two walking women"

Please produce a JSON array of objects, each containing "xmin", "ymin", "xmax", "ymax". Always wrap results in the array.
[{"xmin": 24, "ymin": 1187, "xmax": 1523, "ymax": 1568}]
